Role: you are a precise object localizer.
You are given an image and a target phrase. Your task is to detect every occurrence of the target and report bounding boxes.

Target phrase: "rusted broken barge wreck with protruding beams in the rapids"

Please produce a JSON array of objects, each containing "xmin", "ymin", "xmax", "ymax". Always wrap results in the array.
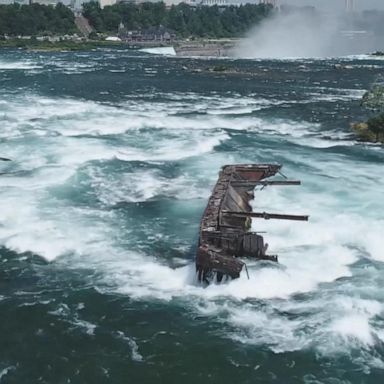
[{"xmin": 196, "ymin": 164, "xmax": 308, "ymax": 283}]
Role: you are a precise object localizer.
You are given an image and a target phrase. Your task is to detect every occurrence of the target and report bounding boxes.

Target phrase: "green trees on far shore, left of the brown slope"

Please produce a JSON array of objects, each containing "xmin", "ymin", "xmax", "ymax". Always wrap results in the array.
[{"xmin": 0, "ymin": 3, "xmax": 76, "ymax": 36}]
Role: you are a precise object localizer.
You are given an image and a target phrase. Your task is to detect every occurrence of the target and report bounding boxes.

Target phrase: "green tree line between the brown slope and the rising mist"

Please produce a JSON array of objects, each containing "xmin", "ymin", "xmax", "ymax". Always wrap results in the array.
[{"xmin": 83, "ymin": 1, "xmax": 273, "ymax": 38}]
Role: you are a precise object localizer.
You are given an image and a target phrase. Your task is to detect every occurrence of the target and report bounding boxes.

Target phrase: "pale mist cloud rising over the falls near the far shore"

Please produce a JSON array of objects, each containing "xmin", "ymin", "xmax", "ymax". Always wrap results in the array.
[{"xmin": 235, "ymin": 8, "xmax": 378, "ymax": 58}]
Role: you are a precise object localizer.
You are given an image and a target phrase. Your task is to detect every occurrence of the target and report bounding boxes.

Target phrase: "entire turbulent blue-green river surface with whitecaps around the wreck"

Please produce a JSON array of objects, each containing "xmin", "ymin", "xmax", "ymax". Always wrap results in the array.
[{"xmin": 0, "ymin": 50, "xmax": 384, "ymax": 384}]
